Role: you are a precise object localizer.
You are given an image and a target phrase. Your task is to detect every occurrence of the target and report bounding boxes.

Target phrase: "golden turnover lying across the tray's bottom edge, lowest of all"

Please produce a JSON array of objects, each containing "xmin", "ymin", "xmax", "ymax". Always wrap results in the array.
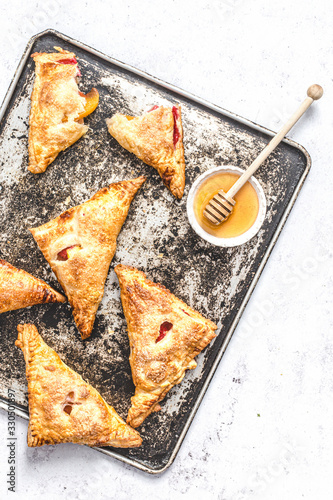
[{"xmin": 15, "ymin": 324, "xmax": 142, "ymax": 448}]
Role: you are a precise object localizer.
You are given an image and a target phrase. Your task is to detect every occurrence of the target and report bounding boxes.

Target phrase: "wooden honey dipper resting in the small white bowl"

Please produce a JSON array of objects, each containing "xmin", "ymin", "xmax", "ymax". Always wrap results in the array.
[{"xmin": 203, "ymin": 84, "xmax": 324, "ymax": 225}]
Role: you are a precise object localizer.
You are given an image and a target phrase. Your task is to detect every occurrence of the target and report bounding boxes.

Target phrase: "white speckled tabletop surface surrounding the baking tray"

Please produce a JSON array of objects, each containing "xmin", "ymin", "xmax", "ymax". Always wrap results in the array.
[{"xmin": 0, "ymin": 0, "xmax": 333, "ymax": 500}]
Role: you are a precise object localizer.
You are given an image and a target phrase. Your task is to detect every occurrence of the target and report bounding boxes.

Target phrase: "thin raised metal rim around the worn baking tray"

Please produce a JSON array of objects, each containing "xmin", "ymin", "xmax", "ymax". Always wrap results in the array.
[{"xmin": 0, "ymin": 28, "xmax": 312, "ymax": 475}]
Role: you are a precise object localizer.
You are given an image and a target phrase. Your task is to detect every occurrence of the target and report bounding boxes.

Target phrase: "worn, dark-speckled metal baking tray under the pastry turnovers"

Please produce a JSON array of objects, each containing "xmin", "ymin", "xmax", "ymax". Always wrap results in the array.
[{"xmin": 0, "ymin": 30, "xmax": 311, "ymax": 473}]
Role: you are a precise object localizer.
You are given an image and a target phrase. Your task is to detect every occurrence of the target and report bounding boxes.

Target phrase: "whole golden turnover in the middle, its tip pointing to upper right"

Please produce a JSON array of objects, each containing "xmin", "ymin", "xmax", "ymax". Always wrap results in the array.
[{"xmin": 30, "ymin": 177, "xmax": 145, "ymax": 339}]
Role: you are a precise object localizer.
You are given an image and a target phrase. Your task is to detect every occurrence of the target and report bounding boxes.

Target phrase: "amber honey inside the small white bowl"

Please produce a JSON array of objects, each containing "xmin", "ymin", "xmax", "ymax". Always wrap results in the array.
[{"xmin": 193, "ymin": 172, "xmax": 259, "ymax": 238}]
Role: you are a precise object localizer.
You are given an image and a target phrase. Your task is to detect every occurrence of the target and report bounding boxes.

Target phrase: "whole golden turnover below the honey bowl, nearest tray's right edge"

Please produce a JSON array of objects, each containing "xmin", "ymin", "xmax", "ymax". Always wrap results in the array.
[{"xmin": 115, "ymin": 264, "xmax": 217, "ymax": 427}]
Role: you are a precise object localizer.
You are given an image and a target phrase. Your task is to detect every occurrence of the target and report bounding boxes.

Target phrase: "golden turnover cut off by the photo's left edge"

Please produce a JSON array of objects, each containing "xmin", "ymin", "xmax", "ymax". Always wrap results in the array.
[{"xmin": 0, "ymin": 259, "xmax": 66, "ymax": 313}]
